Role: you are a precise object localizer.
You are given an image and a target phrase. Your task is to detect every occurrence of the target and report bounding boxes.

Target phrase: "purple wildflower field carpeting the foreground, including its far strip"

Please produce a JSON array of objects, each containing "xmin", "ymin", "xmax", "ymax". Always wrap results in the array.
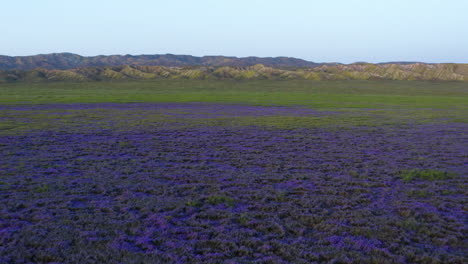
[{"xmin": 0, "ymin": 103, "xmax": 468, "ymax": 263}]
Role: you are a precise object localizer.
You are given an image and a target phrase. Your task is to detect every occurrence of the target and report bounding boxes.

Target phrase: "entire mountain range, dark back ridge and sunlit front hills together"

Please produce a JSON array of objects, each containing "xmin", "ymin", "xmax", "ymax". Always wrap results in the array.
[{"xmin": 0, "ymin": 53, "xmax": 468, "ymax": 83}]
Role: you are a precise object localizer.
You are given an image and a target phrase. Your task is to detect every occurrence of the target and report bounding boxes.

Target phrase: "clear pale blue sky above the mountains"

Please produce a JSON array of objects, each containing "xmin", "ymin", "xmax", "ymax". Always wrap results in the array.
[{"xmin": 0, "ymin": 0, "xmax": 468, "ymax": 63}]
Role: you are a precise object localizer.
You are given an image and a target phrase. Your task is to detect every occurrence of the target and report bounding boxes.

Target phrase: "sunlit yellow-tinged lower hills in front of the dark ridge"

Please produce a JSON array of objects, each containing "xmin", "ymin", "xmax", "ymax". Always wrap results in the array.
[{"xmin": 0, "ymin": 63, "xmax": 468, "ymax": 83}]
